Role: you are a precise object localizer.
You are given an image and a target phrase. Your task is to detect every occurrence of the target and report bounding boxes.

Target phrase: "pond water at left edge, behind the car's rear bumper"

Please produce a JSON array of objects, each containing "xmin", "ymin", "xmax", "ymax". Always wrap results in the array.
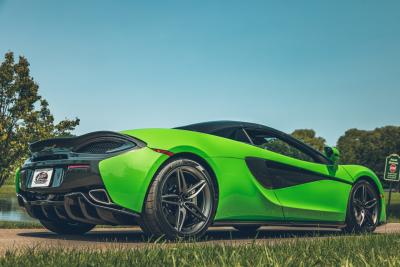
[{"xmin": 0, "ymin": 195, "xmax": 35, "ymax": 222}]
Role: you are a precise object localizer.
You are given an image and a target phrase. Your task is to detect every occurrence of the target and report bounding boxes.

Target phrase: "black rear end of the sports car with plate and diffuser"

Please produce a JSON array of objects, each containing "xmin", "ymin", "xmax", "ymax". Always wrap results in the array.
[{"xmin": 16, "ymin": 132, "xmax": 145, "ymax": 225}]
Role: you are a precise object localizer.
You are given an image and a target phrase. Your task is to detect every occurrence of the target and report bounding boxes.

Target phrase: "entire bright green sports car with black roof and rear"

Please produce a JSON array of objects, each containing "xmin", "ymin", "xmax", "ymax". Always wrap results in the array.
[{"xmin": 16, "ymin": 121, "xmax": 386, "ymax": 239}]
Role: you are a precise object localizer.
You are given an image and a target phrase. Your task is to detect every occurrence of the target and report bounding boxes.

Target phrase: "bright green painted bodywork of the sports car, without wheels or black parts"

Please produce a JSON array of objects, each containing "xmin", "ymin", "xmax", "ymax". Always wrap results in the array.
[{"xmin": 94, "ymin": 129, "xmax": 386, "ymax": 223}]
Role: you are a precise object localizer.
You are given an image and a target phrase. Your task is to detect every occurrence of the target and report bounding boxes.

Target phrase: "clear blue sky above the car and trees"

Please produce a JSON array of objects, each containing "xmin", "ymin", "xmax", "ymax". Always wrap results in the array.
[{"xmin": 0, "ymin": 0, "xmax": 400, "ymax": 147}]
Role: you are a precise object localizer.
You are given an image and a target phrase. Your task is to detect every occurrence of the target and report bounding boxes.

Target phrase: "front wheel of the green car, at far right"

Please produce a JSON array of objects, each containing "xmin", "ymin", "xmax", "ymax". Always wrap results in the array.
[{"xmin": 343, "ymin": 180, "xmax": 380, "ymax": 233}]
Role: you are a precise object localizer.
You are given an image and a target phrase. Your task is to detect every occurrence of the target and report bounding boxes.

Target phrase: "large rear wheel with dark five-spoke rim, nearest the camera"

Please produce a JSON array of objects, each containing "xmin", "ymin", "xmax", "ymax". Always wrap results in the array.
[{"xmin": 140, "ymin": 158, "xmax": 217, "ymax": 239}]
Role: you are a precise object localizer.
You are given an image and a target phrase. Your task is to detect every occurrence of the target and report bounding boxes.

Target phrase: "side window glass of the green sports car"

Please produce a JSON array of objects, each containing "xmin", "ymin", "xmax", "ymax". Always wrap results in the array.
[{"xmin": 246, "ymin": 129, "xmax": 315, "ymax": 162}]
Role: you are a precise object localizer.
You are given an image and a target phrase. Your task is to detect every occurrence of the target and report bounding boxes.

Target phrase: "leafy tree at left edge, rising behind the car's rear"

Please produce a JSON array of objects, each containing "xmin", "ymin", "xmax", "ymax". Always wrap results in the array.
[{"xmin": 0, "ymin": 52, "xmax": 79, "ymax": 186}]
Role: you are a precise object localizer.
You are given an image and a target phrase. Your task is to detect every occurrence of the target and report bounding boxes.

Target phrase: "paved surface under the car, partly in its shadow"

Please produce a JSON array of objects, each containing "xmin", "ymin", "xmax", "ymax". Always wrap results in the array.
[{"xmin": 0, "ymin": 223, "xmax": 400, "ymax": 255}]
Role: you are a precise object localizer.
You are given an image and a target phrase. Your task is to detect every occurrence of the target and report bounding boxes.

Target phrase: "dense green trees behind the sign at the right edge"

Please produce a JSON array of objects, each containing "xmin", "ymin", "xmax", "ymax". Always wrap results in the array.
[{"xmin": 337, "ymin": 126, "xmax": 400, "ymax": 177}]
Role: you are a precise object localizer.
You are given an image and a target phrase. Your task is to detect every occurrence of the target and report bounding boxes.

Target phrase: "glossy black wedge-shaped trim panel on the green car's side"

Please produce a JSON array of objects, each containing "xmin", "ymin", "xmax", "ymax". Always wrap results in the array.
[{"xmin": 246, "ymin": 157, "xmax": 352, "ymax": 189}]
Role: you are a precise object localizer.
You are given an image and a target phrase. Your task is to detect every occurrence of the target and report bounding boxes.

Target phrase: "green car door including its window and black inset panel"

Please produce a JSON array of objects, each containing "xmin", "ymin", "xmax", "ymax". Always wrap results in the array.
[{"xmin": 245, "ymin": 128, "xmax": 352, "ymax": 224}]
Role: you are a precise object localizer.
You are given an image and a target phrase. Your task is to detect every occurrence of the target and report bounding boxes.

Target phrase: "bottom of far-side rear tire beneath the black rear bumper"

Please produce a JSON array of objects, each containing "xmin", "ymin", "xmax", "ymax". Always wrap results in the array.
[{"xmin": 40, "ymin": 220, "xmax": 95, "ymax": 235}]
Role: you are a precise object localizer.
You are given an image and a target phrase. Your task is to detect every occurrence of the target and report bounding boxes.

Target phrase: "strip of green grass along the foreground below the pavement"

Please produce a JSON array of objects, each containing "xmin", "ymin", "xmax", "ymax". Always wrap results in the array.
[{"xmin": 0, "ymin": 235, "xmax": 400, "ymax": 267}]
